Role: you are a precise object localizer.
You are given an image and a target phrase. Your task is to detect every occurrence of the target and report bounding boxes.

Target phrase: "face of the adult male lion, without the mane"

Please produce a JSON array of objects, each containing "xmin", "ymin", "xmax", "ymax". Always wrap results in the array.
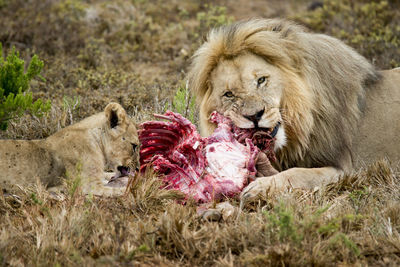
[{"xmin": 203, "ymin": 53, "xmax": 286, "ymax": 149}]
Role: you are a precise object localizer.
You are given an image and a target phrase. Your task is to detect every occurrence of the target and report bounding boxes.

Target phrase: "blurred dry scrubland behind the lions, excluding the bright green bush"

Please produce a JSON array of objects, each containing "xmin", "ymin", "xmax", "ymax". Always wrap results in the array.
[{"xmin": 0, "ymin": 0, "xmax": 400, "ymax": 138}]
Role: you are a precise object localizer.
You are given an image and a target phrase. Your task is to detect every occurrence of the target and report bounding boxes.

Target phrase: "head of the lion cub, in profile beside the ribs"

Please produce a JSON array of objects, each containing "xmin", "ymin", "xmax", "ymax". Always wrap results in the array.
[{"xmin": 103, "ymin": 103, "xmax": 139, "ymax": 175}]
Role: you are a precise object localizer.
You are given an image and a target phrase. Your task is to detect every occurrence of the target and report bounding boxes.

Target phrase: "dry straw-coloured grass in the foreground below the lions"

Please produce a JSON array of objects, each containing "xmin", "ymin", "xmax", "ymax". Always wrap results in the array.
[{"xmin": 0, "ymin": 161, "xmax": 400, "ymax": 266}]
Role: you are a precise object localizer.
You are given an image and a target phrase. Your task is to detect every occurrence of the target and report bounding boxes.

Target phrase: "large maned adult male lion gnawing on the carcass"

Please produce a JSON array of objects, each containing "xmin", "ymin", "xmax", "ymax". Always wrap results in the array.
[{"xmin": 188, "ymin": 19, "xmax": 400, "ymax": 201}]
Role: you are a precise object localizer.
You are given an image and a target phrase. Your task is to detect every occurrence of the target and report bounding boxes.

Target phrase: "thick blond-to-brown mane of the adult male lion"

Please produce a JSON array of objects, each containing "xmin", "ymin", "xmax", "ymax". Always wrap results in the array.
[{"xmin": 189, "ymin": 19, "xmax": 399, "ymax": 174}]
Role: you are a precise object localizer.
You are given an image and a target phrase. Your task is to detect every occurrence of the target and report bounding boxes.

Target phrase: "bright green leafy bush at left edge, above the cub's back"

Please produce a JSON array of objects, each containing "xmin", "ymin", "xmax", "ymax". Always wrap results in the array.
[{"xmin": 0, "ymin": 44, "xmax": 50, "ymax": 130}]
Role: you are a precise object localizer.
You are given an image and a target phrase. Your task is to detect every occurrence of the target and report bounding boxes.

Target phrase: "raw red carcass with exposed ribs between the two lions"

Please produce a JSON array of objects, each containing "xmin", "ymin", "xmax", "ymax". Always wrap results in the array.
[{"xmin": 139, "ymin": 111, "xmax": 274, "ymax": 202}]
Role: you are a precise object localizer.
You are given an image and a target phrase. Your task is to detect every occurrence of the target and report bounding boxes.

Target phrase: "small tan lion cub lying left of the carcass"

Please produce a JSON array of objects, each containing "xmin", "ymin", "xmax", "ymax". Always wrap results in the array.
[{"xmin": 0, "ymin": 103, "xmax": 138, "ymax": 196}]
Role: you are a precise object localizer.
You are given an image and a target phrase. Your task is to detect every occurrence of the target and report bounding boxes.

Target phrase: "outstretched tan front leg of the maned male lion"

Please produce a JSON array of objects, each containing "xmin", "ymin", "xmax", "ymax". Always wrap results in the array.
[{"xmin": 241, "ymin": 167, "xmax": 343, "ymax": 202}]
